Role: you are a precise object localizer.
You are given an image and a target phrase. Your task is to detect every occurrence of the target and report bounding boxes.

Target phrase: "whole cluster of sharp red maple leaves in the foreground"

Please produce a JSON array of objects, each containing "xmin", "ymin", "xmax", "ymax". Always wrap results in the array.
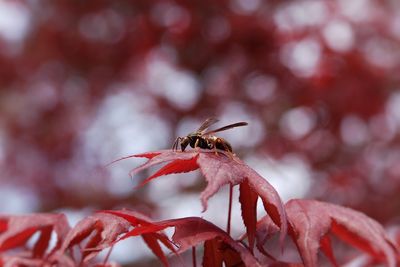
[{"xmin": 0, "ymin": 150, "xmax": 400, "ymax": 267}]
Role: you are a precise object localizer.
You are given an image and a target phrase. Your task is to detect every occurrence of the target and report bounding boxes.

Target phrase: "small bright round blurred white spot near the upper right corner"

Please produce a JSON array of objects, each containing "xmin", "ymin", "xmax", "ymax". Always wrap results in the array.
[{"xmin": 322, "ymin": 20, "xmax": 354, "ymax": 52}]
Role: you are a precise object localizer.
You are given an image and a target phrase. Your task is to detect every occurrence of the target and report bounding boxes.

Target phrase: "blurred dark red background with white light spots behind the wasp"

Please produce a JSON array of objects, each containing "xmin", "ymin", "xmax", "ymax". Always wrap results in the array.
[{"xmin": 0, "ymin": 0, "xmax": 400, "ymax": 262}]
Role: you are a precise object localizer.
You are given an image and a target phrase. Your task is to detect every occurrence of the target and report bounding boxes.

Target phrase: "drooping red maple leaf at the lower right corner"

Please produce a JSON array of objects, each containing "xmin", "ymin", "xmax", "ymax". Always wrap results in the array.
[{"xmin": 285, "ymin": 199, "xmax": 398, "ymax": 267}]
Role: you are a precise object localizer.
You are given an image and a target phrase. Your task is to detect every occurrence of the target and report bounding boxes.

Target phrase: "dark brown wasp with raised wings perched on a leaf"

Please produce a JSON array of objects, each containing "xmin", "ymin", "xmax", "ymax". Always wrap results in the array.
[{"xmin": 172, "ymin": 118, "xmax": 248, "ymax": 153}]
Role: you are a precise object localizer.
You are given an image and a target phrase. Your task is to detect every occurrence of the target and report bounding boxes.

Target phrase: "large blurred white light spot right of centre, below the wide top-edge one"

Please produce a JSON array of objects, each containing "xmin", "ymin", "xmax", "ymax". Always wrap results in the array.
[{"xmin": 280, "ymin": 38, "xmax": 321, "ymax": 77}]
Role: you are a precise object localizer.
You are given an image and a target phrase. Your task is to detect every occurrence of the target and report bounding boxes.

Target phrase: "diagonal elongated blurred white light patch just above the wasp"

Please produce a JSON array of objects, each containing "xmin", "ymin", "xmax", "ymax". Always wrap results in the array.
[{"xmin": 146, "ymin": 53, "xmax": 200, "ymax": 110}]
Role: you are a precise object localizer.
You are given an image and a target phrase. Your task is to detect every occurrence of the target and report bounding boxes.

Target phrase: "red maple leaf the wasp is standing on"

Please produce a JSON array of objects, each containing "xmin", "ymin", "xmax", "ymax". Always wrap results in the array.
[{"xmin": 115, "ymin": 150, "xmax": 287, "ymax": 250}]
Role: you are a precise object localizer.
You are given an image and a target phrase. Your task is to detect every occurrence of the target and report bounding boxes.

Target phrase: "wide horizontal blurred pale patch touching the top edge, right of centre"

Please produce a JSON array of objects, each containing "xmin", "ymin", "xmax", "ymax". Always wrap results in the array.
[{"xmin": 274, "ymin": 1, "xmax": 328, "ymax": 31}]
